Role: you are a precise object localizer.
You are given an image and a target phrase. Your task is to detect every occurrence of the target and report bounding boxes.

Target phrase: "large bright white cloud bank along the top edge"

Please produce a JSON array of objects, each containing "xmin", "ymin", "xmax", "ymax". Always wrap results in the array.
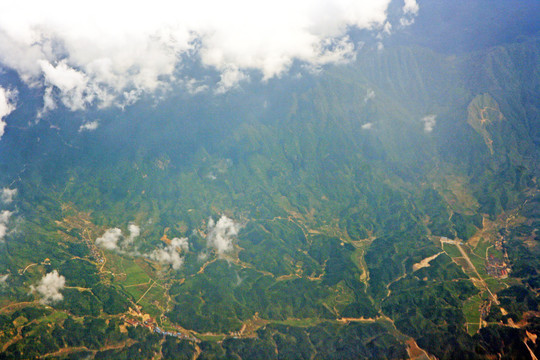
[{"xmin": 0, "ymin": 0, "xmax": 418, "ymax": 109}]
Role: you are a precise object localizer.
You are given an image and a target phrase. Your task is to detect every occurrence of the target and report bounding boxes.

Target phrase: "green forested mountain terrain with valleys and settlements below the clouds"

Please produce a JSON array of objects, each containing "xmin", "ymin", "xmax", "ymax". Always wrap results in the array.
[{"xmin": 0, "ymin": 29, "xmax": 540, "ymax": 359}]
